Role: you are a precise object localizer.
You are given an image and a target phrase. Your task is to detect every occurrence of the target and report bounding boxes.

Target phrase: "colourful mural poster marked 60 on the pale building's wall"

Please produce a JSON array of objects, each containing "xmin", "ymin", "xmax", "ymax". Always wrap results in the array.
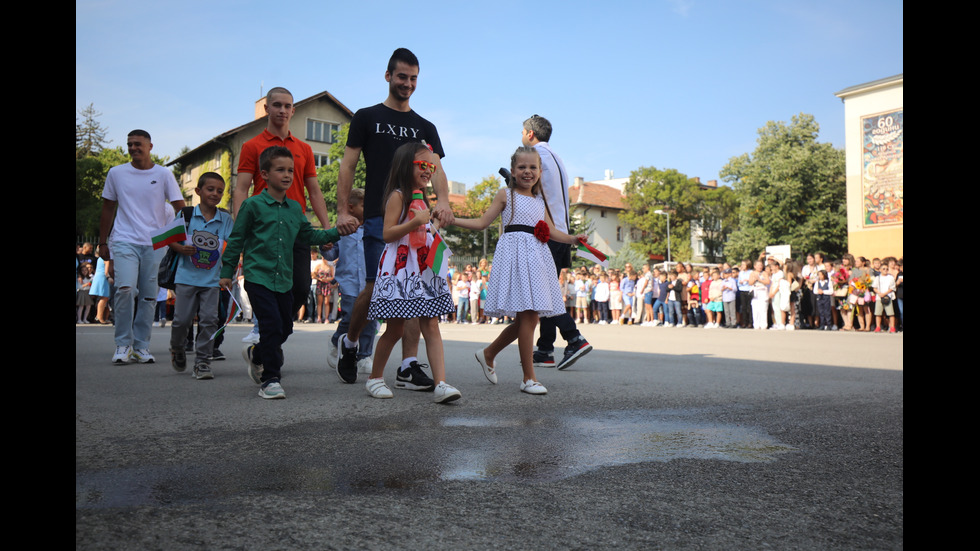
[{"xmin": 861, "ymin": 108, "xmax": 905, "ymax": 226}]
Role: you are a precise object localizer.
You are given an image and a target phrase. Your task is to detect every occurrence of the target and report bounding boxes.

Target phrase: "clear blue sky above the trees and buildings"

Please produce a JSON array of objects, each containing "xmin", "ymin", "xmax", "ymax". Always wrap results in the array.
[{"xmin": 75, "ymin": 0, "xmax": 904, "ymax": 190}]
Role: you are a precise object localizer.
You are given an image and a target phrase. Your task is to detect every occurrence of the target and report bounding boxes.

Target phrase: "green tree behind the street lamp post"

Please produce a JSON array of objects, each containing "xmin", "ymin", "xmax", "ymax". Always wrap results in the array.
[{"xmin": 620, "ymin": 167, "xmax": 702, "ymax": 260}]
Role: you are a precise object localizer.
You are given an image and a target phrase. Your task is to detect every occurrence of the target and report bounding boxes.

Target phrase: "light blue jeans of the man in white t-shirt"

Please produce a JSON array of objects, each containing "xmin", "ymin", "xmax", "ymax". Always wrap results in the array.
[{"xmin": 109, "ymin": 242, "xmax": 166, "ymax": 349}]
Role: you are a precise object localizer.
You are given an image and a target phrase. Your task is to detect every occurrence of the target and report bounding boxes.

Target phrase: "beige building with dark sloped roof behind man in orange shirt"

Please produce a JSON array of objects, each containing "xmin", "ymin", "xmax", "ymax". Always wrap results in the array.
[{"xmin": 169, "ymin": 91, "xmax": 353, "ymax": 211}]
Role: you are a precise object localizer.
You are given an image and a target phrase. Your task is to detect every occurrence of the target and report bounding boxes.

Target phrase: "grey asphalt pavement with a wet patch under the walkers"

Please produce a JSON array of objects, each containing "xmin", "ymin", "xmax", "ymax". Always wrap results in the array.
[{"xmin": 75, "ymin": 324, "xmax": 904, "ymax": 550}]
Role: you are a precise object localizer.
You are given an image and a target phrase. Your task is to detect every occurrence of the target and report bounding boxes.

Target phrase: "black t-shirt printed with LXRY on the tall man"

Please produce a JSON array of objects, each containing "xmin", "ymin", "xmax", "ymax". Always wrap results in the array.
[{"xmin": 347, "ymin": 103, "xmax": 446, "ymax": 218}]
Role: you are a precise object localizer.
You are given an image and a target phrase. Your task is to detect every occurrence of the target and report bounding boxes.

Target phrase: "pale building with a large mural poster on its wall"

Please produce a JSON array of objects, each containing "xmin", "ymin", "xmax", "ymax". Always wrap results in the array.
[{"xmin": 834, "ymin": 75, "xmax": 905, "ymax": 258}]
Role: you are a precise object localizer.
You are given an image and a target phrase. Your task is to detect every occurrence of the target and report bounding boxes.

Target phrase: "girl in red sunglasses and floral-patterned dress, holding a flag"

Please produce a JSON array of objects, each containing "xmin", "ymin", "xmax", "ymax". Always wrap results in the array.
[{"xmin": 364, "ymin": 142, "xmax": 460, "ymax": 403}]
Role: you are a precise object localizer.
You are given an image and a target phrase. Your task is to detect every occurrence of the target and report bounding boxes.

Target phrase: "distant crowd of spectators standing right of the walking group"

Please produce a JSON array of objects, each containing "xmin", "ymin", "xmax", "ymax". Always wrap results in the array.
[{"xmin": 544, "ymin": 253, "xmax": 904, "ymax": 333}]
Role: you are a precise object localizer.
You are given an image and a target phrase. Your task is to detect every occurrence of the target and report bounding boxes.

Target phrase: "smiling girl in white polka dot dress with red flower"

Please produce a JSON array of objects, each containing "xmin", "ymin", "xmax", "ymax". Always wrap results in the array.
[{"xmin": 455, "ymin": 146, "xmax": 585, "ymax": 394}]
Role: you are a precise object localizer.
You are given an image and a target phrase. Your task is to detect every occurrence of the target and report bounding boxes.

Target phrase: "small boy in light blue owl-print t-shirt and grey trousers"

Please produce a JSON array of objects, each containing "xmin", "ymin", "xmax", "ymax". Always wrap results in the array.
[{"xmin": 170, "ymin": 172, "xmax": 234, "ymax": 379}]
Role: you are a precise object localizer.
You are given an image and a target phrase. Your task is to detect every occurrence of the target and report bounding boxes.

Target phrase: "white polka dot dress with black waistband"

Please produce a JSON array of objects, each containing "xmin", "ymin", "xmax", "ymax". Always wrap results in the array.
[{"xmin": 483, "ymin": 192, "xmax": 565, "ymax": 317}]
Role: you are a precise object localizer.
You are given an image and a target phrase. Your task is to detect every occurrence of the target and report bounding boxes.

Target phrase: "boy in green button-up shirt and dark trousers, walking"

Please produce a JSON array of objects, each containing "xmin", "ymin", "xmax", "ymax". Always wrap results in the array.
[{"xmin": 219, "ymin": 146, "xmax": 340, "ymax": 399}]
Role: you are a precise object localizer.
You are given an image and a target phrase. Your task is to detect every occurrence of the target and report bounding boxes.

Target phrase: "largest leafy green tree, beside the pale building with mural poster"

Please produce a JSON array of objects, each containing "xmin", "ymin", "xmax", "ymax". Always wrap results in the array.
[{"xmin": 721, "ymin": 113, "xmax": 847, "ymax": 259}]
